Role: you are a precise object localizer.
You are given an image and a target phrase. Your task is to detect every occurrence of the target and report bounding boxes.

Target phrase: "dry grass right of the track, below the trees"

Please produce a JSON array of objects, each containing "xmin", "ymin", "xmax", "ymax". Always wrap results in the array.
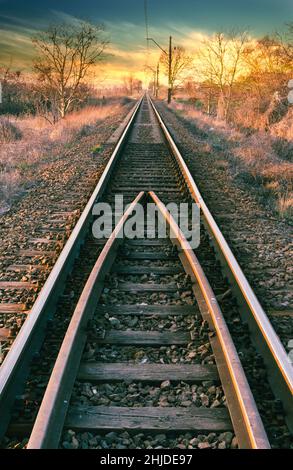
[{"xmin": 171, "ymin": 103, "xmax": 293, "ymax": 218}]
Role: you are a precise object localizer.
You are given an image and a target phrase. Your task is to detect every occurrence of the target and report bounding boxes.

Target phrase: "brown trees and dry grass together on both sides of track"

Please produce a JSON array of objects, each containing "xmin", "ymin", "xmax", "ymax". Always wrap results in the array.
[{"xmin": 0, "ymin": 17, "xmax": 293, "ymax": 216}]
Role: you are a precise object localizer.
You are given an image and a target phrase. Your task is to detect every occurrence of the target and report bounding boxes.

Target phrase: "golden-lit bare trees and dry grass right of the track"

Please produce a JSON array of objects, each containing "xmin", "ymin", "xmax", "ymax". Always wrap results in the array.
[{"xmin": 159, "ymin": 22, "xmax": 293, "ymax": 217}]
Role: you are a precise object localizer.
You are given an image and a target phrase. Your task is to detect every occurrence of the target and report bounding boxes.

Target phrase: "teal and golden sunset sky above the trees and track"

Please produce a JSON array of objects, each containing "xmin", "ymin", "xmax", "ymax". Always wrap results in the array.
[{"xmin": 0, "ymin": 0, "xmax": 293, "ymax": 83}]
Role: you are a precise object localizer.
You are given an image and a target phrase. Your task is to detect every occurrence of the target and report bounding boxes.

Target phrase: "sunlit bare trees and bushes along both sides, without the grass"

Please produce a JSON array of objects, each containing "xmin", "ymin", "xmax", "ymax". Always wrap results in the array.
[{"xmin": 0, "ymin": 21, "xmax": 293, "ymax": 127}]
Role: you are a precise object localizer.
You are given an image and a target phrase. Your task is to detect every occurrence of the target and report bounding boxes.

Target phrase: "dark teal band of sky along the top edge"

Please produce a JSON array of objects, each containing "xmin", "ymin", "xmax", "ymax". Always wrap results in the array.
[{"xmin": 0, "ymin": 0, "xmax": 293, "ymax": 33}]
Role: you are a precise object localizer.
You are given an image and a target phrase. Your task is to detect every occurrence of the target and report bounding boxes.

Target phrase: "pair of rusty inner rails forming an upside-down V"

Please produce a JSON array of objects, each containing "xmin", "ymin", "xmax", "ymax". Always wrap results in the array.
[{"xmin": 28, "ymin": 192, "xmax": 270, "ymax": 449}]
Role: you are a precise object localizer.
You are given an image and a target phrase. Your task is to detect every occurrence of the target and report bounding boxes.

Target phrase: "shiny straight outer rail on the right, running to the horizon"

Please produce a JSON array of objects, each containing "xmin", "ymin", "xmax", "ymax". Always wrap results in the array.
[{"xmin": 148, "ymin": 97, "xmax": 293, "ymax": 432}]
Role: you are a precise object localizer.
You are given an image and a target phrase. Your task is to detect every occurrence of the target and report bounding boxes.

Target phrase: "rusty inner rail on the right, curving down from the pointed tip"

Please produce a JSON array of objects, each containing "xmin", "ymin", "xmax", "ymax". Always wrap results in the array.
[{"xmin": 149, "ymin": 191, "xmax": 270, "ymax": 449}]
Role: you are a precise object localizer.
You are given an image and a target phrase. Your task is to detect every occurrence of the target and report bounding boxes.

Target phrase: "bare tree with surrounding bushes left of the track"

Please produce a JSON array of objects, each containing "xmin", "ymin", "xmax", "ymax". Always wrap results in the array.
[{"xmin": 0, "ymin": 21, "xmax": 109, "ymax": 123}]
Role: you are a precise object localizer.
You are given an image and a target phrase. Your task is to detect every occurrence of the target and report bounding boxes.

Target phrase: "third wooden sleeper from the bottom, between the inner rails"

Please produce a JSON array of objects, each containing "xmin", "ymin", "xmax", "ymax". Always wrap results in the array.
[{"xmin": 97, "ymin": 330, "xmax": 191, "ymax": 346}]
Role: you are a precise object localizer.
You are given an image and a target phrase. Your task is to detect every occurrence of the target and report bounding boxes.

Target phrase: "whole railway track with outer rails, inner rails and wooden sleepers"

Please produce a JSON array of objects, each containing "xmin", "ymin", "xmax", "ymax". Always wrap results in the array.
[{"xmin": 0, "ymin": 97, "xmax": 293, "ymax": 448}]
